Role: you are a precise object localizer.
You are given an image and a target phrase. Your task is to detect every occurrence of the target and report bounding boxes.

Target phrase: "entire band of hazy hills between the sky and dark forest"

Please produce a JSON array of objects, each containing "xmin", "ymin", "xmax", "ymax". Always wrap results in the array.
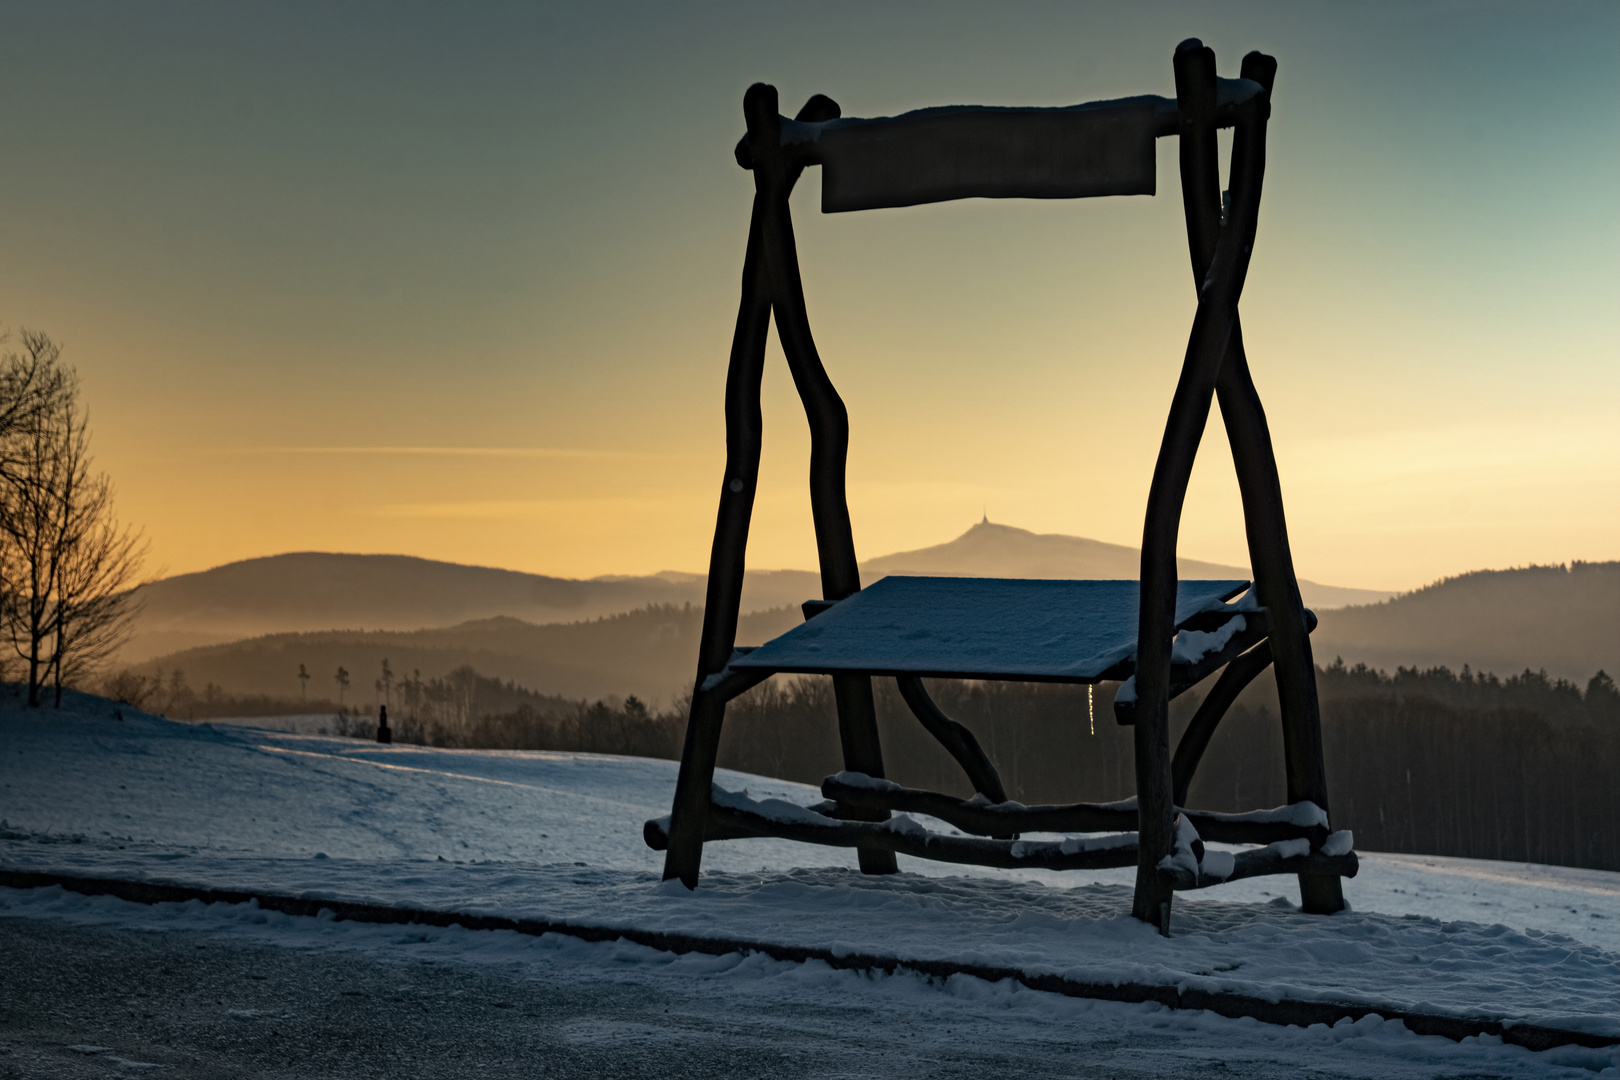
[{"xmin": 125, "ymin": 521, "xmax": 1620, "ymax": 701}]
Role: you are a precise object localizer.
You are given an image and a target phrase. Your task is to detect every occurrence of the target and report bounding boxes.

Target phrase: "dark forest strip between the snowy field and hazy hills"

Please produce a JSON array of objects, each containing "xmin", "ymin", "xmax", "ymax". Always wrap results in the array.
[{"xmin": 133, "ymin": 662, "xmax": 1620, "ymax": 870}]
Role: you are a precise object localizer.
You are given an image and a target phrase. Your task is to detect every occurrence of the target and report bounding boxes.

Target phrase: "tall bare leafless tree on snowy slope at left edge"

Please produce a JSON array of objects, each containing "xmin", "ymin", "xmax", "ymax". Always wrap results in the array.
[{"xmin": 0, "ymin": 329, "xmax": 146, "ymax": 708}]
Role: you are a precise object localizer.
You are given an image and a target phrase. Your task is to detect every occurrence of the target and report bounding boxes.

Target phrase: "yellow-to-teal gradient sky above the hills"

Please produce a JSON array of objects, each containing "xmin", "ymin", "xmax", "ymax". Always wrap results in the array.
[{"xmin": 0, "ymin": 0, "xmax": 1620, "ymax": 588}]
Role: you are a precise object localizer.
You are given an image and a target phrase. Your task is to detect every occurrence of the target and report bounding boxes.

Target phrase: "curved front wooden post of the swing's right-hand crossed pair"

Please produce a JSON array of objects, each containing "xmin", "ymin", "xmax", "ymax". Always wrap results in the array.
[{"xmin": 1131, "ymin": 40, "xmax": 1270, "ymax": 934}]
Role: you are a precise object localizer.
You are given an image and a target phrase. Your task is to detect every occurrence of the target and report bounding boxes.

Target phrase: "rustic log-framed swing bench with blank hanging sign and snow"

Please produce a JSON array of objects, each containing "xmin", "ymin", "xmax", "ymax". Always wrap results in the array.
[{"xmin": 645, "ymin": 40, "xmax": 1356, "ymax": 933}]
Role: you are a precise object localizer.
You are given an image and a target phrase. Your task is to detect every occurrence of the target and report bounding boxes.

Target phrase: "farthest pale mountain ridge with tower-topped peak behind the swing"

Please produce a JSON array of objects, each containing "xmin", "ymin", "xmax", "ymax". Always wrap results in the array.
[{"xmin": 120, "ymin": 521, "xmax": 1388, "ymax": 664}]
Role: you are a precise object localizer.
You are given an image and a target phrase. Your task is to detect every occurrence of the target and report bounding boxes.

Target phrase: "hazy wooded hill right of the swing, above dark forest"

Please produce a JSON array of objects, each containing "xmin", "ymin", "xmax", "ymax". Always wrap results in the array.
[{"xmin": 1311, "ymin": 562, "xmax": 1620, "ymax": 687}]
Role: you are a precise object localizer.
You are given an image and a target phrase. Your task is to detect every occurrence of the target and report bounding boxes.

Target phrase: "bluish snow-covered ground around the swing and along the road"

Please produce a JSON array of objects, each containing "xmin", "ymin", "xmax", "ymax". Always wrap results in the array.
[{"xmin": 0, "ymin": 698, "xmax": 1620, "ymax": 1075}]
